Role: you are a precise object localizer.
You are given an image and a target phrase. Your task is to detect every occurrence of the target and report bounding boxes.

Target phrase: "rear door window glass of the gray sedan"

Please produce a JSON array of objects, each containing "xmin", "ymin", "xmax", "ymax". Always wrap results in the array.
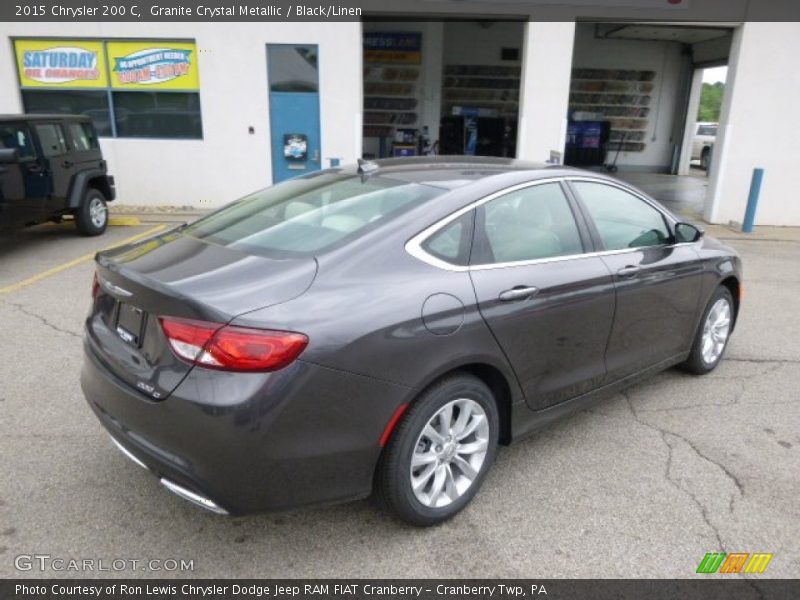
[{"xmin": 470, "ymin": 183, "xmax": 584, "ymax": 265}]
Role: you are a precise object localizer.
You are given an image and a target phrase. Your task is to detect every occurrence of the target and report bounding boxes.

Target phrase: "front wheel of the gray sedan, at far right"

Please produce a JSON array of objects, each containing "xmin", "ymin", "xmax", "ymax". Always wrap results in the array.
[{"xmin": 681, "ymin": 285, "xmax": 735, "ymax": 375}]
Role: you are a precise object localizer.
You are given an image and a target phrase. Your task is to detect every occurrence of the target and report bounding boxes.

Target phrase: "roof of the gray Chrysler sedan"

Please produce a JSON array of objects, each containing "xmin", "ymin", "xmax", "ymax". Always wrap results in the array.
[{"xmin": 346, "ymin": 156, "xmax": 572, "ymax": 189}]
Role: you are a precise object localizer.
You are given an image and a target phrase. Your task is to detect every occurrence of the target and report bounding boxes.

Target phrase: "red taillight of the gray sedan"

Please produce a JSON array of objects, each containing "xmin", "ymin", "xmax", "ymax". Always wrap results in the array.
[{"xmin": 159, "ymin": 317, "xmax": 308, "ymax": 371}]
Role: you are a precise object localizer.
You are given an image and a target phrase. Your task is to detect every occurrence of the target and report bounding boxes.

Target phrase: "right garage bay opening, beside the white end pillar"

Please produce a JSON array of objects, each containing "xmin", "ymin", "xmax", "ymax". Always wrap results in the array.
[{"xmin": 564, "ymin": 23, "xmax": 732, "ymax": 217}]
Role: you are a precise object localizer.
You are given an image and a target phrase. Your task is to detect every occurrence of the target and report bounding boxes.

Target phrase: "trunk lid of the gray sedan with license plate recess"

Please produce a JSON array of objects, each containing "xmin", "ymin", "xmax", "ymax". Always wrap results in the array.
[{"xmin": 87, "ymin": 232, "xmax": 317, "ymax": 400}]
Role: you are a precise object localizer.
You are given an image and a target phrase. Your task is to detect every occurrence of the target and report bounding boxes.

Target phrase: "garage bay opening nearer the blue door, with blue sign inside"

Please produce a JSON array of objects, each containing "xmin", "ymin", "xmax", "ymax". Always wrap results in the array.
[{"xmin": 362, "ymin": 21, "xmax": 524, "ymax": 158}]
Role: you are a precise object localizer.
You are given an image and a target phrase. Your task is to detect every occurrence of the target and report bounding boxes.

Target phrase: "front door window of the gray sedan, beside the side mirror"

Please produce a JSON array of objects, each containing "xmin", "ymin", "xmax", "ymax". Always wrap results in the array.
[{"xmin": 572, "ymin": 181, "xmax": 672, "ymax": 250}]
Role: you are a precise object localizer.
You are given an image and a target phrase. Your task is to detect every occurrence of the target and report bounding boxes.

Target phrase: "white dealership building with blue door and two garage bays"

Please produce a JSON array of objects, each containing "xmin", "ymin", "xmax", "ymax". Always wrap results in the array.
[{"xmin": 0, "ymin": 0, "xmax": 800, "ymax": 226}]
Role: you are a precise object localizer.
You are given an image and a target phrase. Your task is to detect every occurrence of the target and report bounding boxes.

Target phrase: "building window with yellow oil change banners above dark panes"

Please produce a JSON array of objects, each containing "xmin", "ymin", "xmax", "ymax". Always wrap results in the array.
[{"xmin": 14, "ymin": 39, "xmax": 203, "ymax": 139}]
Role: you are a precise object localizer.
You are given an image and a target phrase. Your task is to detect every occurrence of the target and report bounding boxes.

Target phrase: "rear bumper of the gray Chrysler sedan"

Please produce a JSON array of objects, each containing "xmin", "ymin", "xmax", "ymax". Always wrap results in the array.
[{"xmin": 81, "ymin": 342, "xmax": 409, "ymax": 514}]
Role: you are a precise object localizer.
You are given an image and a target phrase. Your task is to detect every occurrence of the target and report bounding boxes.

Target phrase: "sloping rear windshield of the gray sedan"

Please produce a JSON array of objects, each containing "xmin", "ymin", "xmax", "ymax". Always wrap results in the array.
[{"xmin": 184, "ymin": 173, "xmax": 447, "ymax": 257}]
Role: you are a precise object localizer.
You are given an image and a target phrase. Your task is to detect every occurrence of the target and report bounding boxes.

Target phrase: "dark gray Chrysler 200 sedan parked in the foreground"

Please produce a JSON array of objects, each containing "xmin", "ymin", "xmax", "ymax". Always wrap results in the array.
[{"xmin": 81, "ymin": 157, "xmax": 742, "ymax": 525}]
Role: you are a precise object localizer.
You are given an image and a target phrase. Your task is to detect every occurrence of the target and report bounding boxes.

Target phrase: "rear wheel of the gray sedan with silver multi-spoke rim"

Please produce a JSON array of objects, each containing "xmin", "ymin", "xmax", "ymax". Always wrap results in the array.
[{"xmin": 375, "ymin": 373, "xmax": 500, "ymax": 526}]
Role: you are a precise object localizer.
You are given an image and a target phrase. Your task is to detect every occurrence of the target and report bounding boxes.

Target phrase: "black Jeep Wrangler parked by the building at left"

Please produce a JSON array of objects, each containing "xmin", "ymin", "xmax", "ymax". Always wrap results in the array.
[{"xmin": 0, "ymin": 115, "xmax": 116, "ymax": 235}]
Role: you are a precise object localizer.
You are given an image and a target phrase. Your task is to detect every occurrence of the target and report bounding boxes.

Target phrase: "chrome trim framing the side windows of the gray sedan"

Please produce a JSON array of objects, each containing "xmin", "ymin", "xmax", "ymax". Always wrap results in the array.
[{"xmin": 405, "ymin": 175, "xmax": 698, "ymax": 273}]
